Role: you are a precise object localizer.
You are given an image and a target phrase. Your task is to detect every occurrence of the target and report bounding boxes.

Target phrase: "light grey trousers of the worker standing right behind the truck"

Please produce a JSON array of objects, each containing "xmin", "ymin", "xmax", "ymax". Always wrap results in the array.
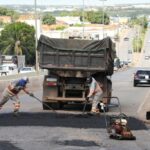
[{"xmin": 92, "ymin": 92, "xmax": 103, "ymax": 110}]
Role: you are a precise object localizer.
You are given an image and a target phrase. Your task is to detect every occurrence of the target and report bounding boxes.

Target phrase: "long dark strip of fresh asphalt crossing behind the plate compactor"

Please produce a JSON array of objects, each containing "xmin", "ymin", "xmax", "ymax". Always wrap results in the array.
[{"xmin": 0, "ymin": 112, "xmax": 147, "ymax": 130}]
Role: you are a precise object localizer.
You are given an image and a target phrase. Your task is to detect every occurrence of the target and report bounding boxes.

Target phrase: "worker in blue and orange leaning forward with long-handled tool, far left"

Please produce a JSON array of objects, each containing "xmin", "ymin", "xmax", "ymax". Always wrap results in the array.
[{"xmin": 0, "ymin": 77, "xmax": 33, "ymax": 113}]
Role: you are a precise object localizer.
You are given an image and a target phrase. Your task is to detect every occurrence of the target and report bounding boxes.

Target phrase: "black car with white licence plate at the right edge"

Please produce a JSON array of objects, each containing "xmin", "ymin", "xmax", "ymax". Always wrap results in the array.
[{"xmin": 133, "ymin": 69, "xmax": 150, "ymax": 87}]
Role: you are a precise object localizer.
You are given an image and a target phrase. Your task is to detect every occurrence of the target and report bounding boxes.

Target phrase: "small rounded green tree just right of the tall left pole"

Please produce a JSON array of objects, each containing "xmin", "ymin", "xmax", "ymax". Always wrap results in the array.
[{"xmin": 42, "ymin": 14, "xmax": 56, "ymax": 25}]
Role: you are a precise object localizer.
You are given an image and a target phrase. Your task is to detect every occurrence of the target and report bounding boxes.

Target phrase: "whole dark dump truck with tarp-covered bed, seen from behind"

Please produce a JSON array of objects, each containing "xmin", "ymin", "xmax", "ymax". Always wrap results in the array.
[{"xmin": 37, "ymin": 35, "xmax": 115, "ymax": 109}]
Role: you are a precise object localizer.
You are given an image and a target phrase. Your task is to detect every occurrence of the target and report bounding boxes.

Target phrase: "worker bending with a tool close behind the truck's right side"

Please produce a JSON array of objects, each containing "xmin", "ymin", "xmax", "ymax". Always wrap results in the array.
[{"xmin": 86, "ymin": 77, "xmax": 103, "ymax": 113}]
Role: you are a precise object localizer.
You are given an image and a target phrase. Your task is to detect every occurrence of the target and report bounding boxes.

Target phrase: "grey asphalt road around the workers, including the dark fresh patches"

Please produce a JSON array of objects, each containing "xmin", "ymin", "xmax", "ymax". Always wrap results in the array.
[{"xmin": 0, "ymin": 69, "xmax": 150, "ymax": 150}]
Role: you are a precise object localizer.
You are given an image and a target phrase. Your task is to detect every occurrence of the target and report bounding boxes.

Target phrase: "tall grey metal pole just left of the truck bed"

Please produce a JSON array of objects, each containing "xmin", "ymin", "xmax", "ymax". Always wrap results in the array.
[{"xmin": 34, "ymin": 0, "xmax": 39, "ymax": 72}]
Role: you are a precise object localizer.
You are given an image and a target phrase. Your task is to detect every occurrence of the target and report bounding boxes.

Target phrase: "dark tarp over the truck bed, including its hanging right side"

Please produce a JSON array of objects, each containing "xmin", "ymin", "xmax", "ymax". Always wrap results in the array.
[{"xmin": 37, "ymin": 35, "xmax": 115, "ymax": 74}]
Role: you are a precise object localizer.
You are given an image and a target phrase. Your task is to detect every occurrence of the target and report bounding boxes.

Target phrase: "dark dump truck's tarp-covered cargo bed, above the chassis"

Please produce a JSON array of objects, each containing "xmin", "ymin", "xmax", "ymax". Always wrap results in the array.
[{"xmin": 37, "ymin": 35, "xmax": 115, "ymax": 75}]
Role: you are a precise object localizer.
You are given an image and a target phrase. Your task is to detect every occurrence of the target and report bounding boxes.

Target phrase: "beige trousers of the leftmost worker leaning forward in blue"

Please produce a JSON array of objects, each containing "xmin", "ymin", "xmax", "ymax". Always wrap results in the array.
[{"xmin": 0, "ymin": 88, "xmax": 20, "ymax": 107}]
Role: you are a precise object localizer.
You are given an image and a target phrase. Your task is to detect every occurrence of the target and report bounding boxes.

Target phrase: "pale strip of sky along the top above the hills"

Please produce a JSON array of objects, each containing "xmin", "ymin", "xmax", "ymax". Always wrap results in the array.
[{"xmin": 0, "ymin": 0, "xmax": 150, "ymax": 6}]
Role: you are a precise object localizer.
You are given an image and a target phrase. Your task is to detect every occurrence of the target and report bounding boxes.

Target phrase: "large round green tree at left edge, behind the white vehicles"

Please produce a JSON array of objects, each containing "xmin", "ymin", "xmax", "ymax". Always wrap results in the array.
[{"xmin": 0, "ymin": 22, "xmax": 35, "ymax": 64}]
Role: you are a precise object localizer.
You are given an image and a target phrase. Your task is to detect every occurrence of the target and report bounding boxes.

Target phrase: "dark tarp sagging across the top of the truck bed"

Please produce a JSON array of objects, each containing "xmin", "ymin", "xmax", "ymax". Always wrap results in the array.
[{"xmin": 37, "ymin": 35, "xmax": 113, "ymax": 54}]
